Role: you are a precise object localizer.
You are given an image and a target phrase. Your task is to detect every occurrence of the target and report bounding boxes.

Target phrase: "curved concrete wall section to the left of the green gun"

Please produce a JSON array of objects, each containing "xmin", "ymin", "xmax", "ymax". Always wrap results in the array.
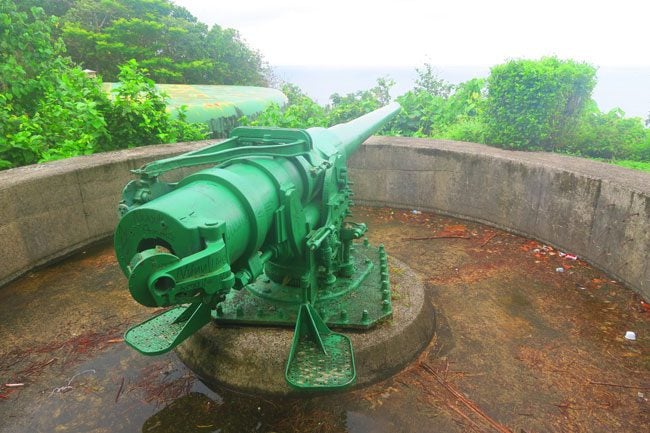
[{"xmin": 0, "ymin": 141, "xmax": 210, "ymax": 286}]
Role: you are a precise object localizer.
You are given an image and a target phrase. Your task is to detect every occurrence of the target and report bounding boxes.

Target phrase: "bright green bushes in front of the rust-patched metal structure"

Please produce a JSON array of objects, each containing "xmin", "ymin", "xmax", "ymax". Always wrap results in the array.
[{"xmin": 0, "ymin": 0, "xmax": 205, "ymax": 169}]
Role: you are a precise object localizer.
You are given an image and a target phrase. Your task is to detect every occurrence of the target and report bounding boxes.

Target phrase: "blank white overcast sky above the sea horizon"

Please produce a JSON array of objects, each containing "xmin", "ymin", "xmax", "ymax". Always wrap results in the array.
[{"xmin": 173, "ymin": 0, "xmax": 650, "ymax": 67}]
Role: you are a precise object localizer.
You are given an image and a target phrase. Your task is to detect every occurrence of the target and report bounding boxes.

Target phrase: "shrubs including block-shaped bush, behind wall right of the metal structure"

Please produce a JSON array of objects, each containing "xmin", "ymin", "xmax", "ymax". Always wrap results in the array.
[{"xmin": 248, "ymin": 58, "xmax": 650, "ymax": 169}]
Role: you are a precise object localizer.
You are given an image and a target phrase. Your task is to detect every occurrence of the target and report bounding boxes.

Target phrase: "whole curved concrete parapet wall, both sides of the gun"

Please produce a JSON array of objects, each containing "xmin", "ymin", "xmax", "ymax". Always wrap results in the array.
[{"xmin": 0, "ymin": 137, "xmax": 650, "ymax": 299}]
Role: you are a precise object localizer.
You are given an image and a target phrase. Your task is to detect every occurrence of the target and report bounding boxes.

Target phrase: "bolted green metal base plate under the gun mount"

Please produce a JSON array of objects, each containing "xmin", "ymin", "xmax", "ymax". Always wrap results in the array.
[{"xmin": 213, "ymin": 243, "xmax": 392, "ymax": 329}]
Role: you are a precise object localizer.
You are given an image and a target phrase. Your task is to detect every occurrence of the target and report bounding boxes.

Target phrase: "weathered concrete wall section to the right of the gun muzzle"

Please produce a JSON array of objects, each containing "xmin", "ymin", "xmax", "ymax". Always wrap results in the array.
[{"xmin": 349, "ymin": 137, "xmax": 650, "ymax": 299}]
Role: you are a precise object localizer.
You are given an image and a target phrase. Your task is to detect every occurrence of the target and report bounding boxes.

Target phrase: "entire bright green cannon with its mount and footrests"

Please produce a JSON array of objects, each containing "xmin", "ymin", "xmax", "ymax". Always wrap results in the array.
[{"xmin": 115, "ymin": 104, "xmax": 400, "ymax": 390}]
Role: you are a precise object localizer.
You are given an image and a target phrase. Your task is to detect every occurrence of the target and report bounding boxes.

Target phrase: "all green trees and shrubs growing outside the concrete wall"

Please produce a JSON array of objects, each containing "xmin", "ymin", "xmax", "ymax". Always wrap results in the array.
[{"xmin": 0, "ymin": 0, "xmax": 650, "ymax": 169}]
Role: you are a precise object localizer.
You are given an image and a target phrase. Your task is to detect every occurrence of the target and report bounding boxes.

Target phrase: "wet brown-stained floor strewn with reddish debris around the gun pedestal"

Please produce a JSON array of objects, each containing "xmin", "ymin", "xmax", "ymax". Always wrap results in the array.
[{"xmin": 0, "ymin": 208, "xmax": 650, "ymax": 433}]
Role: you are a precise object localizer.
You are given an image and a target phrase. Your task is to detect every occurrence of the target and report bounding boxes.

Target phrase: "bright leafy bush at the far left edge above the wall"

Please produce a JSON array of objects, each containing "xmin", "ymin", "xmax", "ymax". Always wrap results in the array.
[{"xmin": 0, "ymin": 0, "xmax": 107, "ymax": 168}]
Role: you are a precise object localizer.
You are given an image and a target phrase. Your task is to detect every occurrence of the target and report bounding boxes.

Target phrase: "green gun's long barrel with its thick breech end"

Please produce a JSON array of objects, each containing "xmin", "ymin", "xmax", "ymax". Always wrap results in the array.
[{"xmin": 115, "ymin": 104, "xmax": 400, "ymax": 306}]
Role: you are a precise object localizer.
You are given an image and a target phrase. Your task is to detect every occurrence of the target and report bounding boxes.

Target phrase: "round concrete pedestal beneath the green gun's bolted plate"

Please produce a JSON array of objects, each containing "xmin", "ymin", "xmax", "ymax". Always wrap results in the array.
[{"xmin": 176, "ymin": 258, "xmax": 435, "ymax": 395}]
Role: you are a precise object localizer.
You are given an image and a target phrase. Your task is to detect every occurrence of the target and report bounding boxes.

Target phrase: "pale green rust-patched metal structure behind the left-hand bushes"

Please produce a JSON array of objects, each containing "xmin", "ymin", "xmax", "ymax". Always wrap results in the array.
[{"xmin": 104, "ymin": 83, "xmax": 287, "ymax": 138}]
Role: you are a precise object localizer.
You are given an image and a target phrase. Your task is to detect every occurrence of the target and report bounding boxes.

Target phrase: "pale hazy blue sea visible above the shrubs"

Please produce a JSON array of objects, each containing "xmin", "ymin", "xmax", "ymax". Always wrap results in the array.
[{"xmin": 273, "ymin": 66, "xmax": 650, "ymax": 119}]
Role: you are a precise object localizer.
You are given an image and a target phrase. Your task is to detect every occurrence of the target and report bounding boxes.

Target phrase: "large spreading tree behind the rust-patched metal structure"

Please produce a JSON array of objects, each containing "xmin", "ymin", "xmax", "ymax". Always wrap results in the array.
[{"xmin": 55, "ymin": 0, "xmax": 267, "ymax": 85}]
